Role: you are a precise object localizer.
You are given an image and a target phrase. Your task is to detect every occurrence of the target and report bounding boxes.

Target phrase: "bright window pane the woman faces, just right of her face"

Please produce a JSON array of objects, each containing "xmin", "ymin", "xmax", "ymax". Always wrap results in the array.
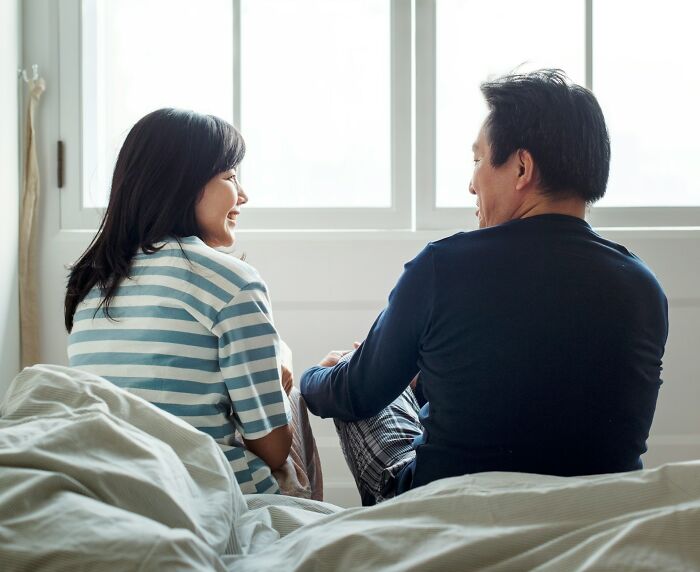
[{"xmin": 241, "ymin": 0, "xmax": 391, "ymax": 207}]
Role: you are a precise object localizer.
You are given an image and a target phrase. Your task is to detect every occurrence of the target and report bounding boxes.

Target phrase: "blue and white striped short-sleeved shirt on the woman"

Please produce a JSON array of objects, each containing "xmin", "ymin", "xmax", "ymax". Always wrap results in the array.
[{"xmin": 68, "ymin": 237, "xmax": 291, "ymax": 493}]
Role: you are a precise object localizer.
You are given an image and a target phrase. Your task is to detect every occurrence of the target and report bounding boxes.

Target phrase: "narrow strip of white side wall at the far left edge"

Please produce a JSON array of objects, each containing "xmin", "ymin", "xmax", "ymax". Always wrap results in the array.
[{"xmin": 0, "ymin": 0, "xmax": 20, "ymax": 395}]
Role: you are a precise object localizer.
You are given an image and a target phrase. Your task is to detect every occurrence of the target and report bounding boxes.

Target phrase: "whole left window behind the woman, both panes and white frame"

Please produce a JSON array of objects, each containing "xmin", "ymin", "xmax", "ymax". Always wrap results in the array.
[{"xmin": 59, "ymin": 0, "xmax": 411, "ymax": 228}]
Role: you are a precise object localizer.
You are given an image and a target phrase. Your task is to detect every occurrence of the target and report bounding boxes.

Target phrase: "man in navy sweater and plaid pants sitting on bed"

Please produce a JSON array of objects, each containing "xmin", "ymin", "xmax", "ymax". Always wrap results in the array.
[{"xmin": 301, "ymin": 70, "xmax": 668, "ymax": 504}]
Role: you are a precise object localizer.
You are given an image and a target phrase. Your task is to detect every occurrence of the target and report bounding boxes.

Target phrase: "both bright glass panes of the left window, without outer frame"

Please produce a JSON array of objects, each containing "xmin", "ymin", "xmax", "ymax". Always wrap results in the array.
[{"xmin": 83, "ymin": 0, "xmax": 391, "ymax": 212}]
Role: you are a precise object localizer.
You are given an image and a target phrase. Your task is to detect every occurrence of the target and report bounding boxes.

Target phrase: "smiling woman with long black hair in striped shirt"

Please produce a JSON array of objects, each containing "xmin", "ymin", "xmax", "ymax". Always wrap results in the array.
[{"xmin": 65, "ymin": 109, "xmax": 320, "ymax": 498}]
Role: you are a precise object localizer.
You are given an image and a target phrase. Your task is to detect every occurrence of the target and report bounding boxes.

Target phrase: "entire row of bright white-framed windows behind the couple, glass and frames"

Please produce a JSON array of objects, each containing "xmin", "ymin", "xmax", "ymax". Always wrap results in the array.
[{"xmin": 57, "ymin": 0, "xmax": 700, "ymax": 229}]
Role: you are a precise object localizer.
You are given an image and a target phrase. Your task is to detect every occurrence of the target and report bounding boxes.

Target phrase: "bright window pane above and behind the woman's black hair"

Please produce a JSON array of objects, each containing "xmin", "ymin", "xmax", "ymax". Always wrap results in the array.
[{"xmin": 82, "ymin": 0, "xmax": 233, "ymax": 208}]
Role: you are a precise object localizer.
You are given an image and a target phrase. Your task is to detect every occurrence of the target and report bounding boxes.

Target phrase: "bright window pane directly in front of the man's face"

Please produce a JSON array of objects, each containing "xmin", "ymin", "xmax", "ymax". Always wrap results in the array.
[{"xmin": 436, "ymin": 0, "xmax": 584, "ymax": 207}]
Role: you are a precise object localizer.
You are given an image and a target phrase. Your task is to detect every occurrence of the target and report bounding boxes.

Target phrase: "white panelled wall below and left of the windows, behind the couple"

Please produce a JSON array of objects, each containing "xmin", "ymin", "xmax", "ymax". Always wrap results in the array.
[{"xmin": 21, "ymin": 0, "xmax": 700, "ymax": 505}]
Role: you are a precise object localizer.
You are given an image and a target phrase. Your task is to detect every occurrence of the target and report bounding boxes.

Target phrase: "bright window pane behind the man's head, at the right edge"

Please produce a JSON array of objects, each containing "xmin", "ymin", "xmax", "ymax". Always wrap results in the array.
[{"xmin": 593, "ymin": 0, "xmax": 700, "ymax": 206}]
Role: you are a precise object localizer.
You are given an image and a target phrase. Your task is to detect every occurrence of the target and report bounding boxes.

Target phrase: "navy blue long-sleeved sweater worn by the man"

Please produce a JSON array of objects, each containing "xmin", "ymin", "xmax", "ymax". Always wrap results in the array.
[{"xmin": 301, "ymin": 215, "xmax": 668, "ymax": 492}]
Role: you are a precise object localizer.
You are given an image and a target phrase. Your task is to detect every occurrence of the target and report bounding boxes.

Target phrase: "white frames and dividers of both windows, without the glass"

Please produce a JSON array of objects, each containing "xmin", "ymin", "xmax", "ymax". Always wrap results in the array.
[{"xmin": 51, "ymin": 0, "xmax": 700, "ymax": 231}]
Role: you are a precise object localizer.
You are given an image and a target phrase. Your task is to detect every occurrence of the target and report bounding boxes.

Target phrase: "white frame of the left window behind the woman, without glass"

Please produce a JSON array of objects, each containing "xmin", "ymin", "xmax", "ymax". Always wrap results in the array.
[{"xmin": 56, "ymin": 0, "xmax": 413, "ymax": 230}]
